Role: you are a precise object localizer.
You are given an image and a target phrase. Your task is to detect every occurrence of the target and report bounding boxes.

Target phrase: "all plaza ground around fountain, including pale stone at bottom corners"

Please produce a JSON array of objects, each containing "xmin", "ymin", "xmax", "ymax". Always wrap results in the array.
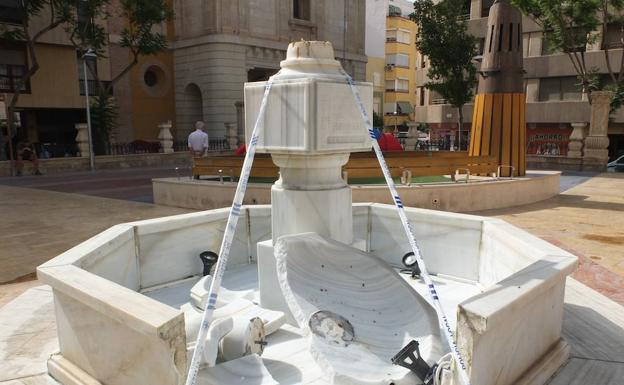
[{"xmin": 0, "ymin": 166, "xmax": 624, "ymax": 385}]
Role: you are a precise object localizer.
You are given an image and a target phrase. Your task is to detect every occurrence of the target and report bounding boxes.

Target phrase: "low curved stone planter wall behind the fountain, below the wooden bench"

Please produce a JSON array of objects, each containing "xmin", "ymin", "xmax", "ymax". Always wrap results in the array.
[{"xmin": 152, "ymin": 171, "xmax": 561, "ymax": 212}]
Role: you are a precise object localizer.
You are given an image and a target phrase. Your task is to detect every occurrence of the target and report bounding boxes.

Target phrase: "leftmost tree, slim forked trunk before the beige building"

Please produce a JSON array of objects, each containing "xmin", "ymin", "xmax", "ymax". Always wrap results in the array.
[{"xmin": 0, "ymin": 0, "xmax": 72, "ymax": 168}]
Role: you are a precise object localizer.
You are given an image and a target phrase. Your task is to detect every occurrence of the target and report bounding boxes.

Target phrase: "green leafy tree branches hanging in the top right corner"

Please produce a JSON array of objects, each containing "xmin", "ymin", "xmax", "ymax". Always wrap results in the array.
[{"xmin": 512, "ymin": 0, "xmax": 624, "ymax": 108}]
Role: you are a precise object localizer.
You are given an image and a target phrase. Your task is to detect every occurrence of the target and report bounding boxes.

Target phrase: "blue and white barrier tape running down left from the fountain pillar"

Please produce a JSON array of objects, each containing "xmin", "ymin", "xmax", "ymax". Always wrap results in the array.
[{"xmin": 186, "ymin": 79, "xmax": 273, "ymax": 385}]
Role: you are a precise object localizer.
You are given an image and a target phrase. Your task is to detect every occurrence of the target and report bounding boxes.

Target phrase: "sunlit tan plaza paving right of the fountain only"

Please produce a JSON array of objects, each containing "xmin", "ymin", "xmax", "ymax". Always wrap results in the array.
[{"xmin": 475, "ymin": 173, "xmax": 624, "ymax": 305}]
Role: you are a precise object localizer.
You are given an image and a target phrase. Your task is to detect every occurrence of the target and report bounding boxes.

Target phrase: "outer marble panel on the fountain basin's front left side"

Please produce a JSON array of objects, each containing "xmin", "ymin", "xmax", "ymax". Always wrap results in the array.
[{"xmin": 47, "ymin": 286, "xmax": 186, "ymax": 385}]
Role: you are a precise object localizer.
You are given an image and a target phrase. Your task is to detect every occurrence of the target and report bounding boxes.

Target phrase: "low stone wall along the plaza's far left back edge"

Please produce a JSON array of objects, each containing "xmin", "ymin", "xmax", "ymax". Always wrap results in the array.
[{"xmin": 0, "ymin": 151, "xmax": 191, "ymax": 177}]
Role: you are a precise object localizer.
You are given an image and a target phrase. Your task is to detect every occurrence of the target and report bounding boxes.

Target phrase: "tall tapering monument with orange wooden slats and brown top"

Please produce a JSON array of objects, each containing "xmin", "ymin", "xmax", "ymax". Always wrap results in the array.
[{"xmin": 469, "ymin": 0, "xmax": 526, "ymax": 176}]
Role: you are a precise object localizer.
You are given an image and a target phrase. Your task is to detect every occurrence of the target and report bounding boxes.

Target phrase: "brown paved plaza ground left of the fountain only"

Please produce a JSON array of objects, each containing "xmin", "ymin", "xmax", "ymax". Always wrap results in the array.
[{"xmin": 0, "ymin": 174, "xmax": 190, "ymax": 290}]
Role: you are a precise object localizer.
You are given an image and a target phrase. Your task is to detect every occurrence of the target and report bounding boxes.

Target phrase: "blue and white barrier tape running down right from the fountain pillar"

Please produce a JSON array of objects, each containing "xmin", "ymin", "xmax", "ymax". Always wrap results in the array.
[{"xmin": 341, "ymin": 70, "xmax": 470, "ymax": 385}]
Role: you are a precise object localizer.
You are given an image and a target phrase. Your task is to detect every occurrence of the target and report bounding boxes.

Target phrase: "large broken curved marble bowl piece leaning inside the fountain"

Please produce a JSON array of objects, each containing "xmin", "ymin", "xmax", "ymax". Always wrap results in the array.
[{"xmin": 275, "ymin": 233, "xmax": 445, "ymax": 385}]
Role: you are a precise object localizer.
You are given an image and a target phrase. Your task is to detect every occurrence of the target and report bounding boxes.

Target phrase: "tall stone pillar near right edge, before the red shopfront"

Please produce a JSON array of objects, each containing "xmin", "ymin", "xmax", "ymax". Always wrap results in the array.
[{"xmin": 583, "ymin": 91, "xmax": 613, "ymax": 166}]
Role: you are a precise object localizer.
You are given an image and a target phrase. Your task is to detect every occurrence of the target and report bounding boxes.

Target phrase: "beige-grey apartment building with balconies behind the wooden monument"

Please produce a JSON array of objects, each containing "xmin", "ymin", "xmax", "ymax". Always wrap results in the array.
[{"xmin": 415, "ymin": 0, "xmax": 624, "ymax": 158}]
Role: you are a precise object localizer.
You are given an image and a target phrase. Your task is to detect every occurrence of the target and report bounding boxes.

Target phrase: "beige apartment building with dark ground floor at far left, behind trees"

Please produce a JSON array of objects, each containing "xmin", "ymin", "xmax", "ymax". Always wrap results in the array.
[{"xmin": 0, "ymin": 1, "xmax": 110, "ymax": 156}]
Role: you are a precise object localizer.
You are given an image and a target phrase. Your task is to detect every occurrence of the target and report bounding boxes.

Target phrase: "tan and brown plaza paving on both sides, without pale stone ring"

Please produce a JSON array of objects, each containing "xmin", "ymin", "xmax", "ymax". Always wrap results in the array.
[{"xmin": 0, "ymin": 168, "xmax": 624, "ymax": 306}]
